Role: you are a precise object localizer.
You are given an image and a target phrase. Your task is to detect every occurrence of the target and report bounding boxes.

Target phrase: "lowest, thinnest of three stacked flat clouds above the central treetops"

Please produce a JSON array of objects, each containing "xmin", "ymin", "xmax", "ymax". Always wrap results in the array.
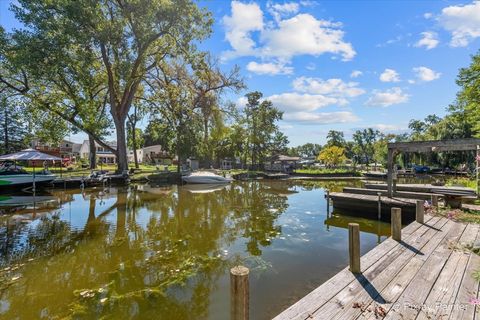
[{"xmin": 283, "ymin": 111, "xmax": 359, "ymax": 124}]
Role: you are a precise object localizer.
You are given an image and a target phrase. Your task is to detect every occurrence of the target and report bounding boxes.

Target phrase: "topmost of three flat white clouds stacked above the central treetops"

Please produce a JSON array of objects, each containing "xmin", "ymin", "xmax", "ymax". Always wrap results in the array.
[{"xmin": 292, "ymin": 77, "xmax": 365, "ymax": 97}]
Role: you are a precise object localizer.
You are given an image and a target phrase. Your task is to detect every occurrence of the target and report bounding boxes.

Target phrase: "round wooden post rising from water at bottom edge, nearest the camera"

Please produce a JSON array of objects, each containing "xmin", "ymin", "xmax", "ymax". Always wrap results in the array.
[{"xmin": 230, "ymin": 266, "xmax": 250, "ymax": 320}]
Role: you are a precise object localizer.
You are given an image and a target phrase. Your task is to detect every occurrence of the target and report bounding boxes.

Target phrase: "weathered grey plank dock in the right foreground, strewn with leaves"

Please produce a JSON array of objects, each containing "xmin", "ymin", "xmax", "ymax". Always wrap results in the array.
[{"xmin": 274, "ymin": 216, "xmax": 480, "ymax": 320}]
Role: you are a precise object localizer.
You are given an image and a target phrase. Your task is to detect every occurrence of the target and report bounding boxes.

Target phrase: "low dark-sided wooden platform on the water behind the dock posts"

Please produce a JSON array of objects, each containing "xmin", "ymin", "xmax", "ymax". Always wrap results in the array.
[{"xmin": 329, "ymin": 192, "xmax": 417, "ymax": 221}]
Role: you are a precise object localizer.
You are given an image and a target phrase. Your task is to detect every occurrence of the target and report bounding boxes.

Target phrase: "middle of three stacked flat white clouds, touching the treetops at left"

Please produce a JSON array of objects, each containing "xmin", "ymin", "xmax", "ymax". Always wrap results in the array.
[{"xmin": 266, "ymin": 92, "xmax": 346, "ymax": 112}]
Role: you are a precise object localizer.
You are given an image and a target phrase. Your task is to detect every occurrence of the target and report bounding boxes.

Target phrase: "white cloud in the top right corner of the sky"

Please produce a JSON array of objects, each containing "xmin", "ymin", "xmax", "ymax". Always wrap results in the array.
[{"xmin": 438, "ymin": 1, "xmax": 480, "ymax": 47}]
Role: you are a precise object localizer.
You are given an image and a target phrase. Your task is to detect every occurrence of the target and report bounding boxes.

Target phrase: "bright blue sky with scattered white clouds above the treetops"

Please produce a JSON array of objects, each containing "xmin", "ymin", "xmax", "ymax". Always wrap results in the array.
[{"xmin": 0, "ymin": 0, "xmax": 480, "ymax": 145}]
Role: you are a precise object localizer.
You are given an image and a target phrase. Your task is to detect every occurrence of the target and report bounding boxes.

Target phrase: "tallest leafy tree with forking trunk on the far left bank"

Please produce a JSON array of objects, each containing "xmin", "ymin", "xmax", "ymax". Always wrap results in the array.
[{"xmin": 0, "ymin": 0, "xmax": 211, "ymax": 171}]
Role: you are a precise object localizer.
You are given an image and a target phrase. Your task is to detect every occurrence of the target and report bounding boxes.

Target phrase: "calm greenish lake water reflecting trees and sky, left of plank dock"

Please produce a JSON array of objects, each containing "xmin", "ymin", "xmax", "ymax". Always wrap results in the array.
[{"xmin": 0, "ymin": 181, "xmax": 390, "ymax": 320}]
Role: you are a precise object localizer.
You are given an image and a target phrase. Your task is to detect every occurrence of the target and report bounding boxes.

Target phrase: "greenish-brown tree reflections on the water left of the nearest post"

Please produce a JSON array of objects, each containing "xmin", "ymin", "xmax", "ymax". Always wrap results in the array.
[{"xmin": 1, "ymin": 182, "xmax": 291, "ymax": 319}]
